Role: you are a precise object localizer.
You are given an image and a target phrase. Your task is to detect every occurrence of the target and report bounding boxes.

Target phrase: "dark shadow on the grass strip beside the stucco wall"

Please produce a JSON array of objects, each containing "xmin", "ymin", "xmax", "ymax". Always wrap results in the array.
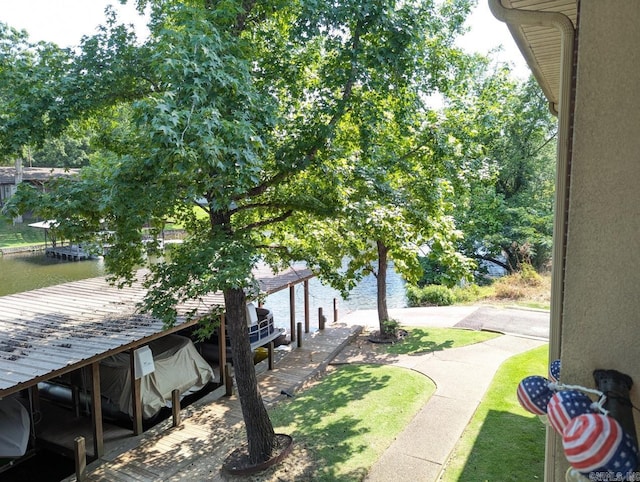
[{"xmin": 444, "ymin": 410, "xmax": 546, "ymax": 482}]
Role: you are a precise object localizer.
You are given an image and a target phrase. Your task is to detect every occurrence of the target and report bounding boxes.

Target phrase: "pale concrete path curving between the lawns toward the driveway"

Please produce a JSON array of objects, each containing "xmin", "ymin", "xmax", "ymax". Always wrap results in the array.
[{"xmin": 336, "ymin": 306, "xmax": 548, "ymax": 482}]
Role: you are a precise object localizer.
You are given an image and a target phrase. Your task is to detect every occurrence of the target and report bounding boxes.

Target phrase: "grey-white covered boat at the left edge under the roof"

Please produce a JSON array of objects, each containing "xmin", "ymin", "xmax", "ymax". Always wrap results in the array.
[{"xmin": 0, "ymin": 398, "xmax": 31, "ymax": 458}]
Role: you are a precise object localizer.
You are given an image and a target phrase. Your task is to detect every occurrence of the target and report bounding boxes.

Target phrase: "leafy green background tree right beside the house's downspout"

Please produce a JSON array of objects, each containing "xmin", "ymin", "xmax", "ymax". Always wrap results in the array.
[{"xmin": 443, "ymin": 62, "xmax": 556, "ymax": 272}]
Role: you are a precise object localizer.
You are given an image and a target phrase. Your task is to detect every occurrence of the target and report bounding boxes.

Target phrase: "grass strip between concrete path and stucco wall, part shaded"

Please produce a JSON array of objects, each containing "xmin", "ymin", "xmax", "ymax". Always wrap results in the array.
[{"xmin": 442, "ymin": 345, "xmax": 548, "ymax": 482}]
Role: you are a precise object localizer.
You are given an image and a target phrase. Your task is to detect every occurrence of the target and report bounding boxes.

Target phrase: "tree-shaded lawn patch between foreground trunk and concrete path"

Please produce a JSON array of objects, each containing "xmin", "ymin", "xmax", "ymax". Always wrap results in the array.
[{"xmin": 271, "ymin": 365, "xmax": 435, "ymax": 482}]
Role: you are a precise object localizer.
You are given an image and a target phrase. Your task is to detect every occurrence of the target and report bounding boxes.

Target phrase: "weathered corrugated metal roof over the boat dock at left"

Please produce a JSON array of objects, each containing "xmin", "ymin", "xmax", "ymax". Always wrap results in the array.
[{"xmin": 0, "ymin": 266, "xmax": 313, "ymax": 398}]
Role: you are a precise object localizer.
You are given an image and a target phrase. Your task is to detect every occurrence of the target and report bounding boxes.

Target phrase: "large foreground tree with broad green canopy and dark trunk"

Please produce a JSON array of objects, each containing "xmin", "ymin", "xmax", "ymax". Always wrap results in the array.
[{"xmin": 0, "ymin": 0, "xmax": 476, "ymax": 463}]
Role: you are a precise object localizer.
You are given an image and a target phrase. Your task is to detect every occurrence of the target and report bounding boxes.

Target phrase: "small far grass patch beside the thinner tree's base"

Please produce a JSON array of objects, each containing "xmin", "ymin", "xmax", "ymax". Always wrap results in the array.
[{"xmin": 387, "ymin": 328, "xmax": 500, "ymax": 355}]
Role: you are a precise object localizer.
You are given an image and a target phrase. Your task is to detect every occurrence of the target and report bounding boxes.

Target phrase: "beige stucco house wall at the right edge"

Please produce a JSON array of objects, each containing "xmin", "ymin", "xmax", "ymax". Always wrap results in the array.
[{"xmin": 556, "ymin": 0, "xmax": 640, "ymax": 474}]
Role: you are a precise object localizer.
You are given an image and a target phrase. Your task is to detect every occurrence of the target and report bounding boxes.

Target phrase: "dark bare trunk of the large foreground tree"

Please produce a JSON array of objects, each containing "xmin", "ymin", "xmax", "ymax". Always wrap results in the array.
[{"xmin": 224, "ymin": 288, "xmax": 275, "ymax": 464}]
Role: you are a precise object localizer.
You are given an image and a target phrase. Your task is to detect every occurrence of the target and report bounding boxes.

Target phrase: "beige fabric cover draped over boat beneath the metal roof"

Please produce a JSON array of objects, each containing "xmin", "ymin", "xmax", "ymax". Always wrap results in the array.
[{"xmin": 100, "ymin": 335, "xmax": 214, "ymax": 418}]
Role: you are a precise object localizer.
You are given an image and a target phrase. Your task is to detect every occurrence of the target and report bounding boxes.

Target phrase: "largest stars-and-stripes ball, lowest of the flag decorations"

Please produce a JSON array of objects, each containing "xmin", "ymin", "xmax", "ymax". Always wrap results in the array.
[{"xmin": 562, "ymin": 413, "xmax": 638, "ymax": 480}]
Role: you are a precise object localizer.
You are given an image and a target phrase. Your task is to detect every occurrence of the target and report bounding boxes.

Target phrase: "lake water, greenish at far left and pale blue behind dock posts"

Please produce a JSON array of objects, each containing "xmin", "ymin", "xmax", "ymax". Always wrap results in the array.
[{"xmin": 0, "ymin": 252, "xmax": 406, "ymax": 328}]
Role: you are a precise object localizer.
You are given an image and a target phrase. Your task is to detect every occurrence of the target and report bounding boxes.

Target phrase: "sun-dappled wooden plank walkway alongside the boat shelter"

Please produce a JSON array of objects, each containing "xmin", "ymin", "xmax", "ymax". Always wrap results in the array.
[{"xmin": 64, "ymin": 324, "xmax": 360, "ymax": 482}]
